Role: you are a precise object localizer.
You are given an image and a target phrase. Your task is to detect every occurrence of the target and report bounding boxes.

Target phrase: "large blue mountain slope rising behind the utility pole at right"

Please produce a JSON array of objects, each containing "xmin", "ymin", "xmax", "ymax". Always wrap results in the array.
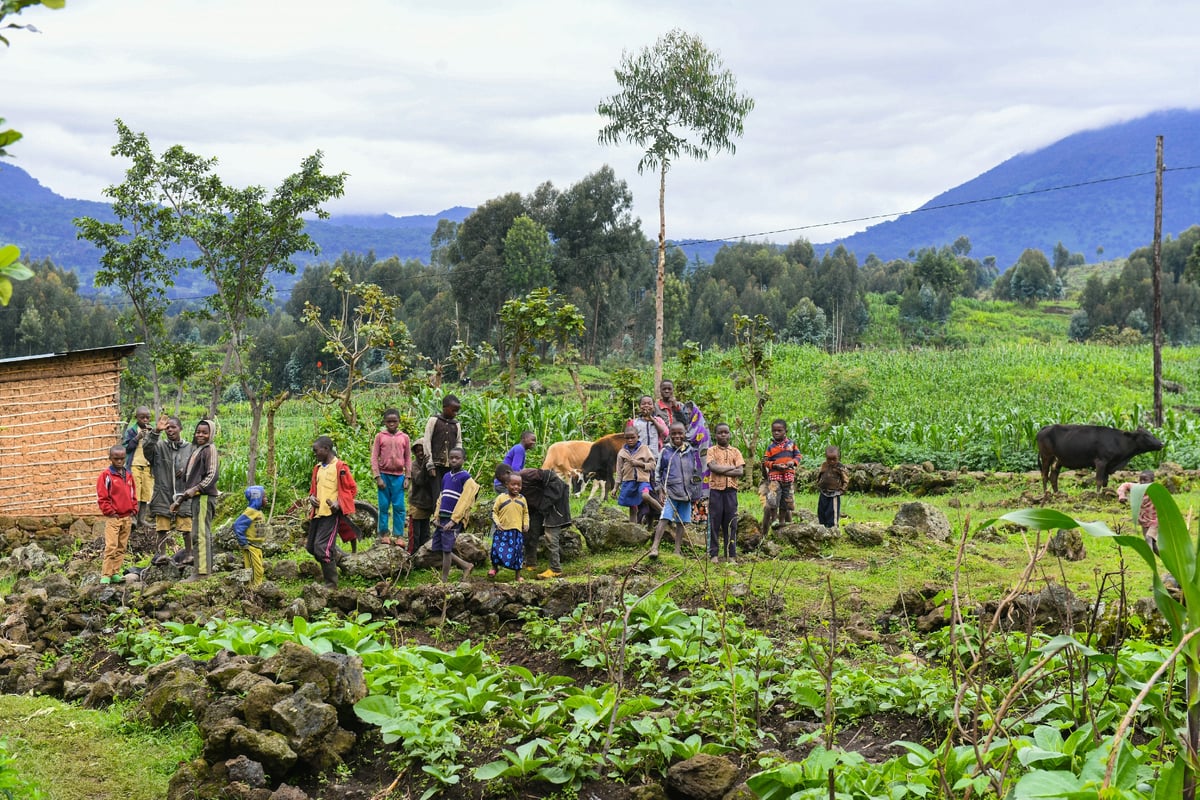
[{"xmin": 816, "ymin": 109, "xmax": 1200, "ymax": 270}]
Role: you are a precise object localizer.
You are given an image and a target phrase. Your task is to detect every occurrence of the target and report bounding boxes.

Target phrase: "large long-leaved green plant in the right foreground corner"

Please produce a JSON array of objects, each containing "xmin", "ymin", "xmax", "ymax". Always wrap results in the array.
[{"xmin": 1000, "ymin": 483, "xmax": 1200, "ymax": 800}]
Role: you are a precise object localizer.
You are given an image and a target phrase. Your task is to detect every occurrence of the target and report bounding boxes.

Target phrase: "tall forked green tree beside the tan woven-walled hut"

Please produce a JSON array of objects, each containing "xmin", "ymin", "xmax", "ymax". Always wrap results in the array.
[{"xmin": 100, "ymin": 120, "xmax": 346, "ymax": 482}]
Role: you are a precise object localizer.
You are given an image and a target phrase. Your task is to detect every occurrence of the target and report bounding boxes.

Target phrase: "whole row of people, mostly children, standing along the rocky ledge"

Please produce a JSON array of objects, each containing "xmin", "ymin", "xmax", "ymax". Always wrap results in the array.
[{"xmin": 96, "ymin": 393, "xmax": 850, "ymax": 588}]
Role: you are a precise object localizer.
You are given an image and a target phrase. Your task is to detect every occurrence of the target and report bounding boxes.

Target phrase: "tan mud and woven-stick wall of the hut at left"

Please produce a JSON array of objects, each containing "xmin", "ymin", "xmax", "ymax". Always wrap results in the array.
[{"xmin": 0, "ymin": 347, "xmax": 133, "ymax": 517}]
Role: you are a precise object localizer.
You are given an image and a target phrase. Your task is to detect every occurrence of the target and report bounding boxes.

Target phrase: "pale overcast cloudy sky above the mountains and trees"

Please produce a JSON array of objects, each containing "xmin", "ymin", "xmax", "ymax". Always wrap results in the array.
[{"xmin": 0, "ymin": 0, "xmax": 1200, "ymax": 242}]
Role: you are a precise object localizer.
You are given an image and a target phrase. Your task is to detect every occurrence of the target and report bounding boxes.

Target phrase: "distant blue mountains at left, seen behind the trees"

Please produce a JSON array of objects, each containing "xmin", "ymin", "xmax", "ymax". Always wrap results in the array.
[{"xmin": 0, "ymin": 162, "xmax": 473, "ymax": 295}]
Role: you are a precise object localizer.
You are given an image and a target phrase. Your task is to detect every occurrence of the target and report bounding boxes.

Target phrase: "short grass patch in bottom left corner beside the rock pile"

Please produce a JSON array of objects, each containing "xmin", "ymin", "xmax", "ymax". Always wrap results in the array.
[{"xmin": 0, "ymin": 694, "xmax": 200, "ymax": 800}]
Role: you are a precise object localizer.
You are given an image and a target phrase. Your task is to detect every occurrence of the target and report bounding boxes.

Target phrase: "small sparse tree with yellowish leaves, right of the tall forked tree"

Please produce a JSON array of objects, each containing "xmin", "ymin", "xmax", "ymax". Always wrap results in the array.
[{"xmin": 304, "ymin": 266, "xmax": 410, "ymax": 428}]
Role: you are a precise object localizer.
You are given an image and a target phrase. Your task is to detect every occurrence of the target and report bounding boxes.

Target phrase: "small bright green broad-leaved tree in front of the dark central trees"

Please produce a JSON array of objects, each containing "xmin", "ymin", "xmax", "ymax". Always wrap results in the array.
[{"xmin": 500, "ymin": 288, "xmax": 583, "ymax": 397}]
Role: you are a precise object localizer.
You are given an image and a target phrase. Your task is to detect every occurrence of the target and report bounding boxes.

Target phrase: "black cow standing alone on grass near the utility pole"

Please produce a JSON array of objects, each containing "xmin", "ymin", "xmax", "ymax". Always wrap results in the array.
[{"xmin": 1037, "ymin": 425, "xmax": 1163, "ymax": 493}]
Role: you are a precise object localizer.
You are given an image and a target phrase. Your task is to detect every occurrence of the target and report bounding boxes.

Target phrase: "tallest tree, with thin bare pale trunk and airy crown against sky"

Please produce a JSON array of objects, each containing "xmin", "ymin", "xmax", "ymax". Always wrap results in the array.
[{"xmin": 596, "ymin": 29, "xmax": 754, "ymax": 386}]
